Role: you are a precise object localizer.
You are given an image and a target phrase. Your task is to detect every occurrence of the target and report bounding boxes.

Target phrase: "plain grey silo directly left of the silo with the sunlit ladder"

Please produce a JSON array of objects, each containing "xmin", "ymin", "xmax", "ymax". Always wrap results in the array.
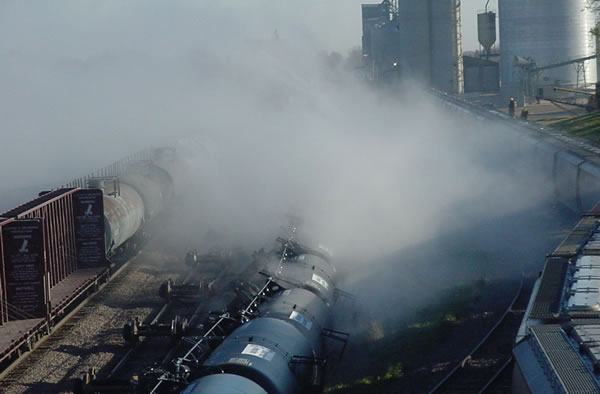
[{"xmin": 397, "ymin": 0, "xmax": 431, "ymax": 84}]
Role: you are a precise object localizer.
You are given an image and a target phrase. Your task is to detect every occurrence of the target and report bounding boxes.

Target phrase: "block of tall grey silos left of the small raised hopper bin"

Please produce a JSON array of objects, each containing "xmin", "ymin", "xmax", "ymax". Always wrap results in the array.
[{"xmin": 362, "ymin": 0, "xmax": 464, "ymax": 94}]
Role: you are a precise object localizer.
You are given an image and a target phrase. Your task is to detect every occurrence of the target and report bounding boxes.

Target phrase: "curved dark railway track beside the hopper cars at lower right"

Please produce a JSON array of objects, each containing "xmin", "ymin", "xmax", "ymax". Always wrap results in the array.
[{"xmin": 429, "ymin": 277, "xmax": 532, "ymax": 394}]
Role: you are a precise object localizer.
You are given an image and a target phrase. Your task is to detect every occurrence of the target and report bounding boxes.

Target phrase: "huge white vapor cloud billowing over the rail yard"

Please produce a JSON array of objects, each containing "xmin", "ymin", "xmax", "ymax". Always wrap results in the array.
[{"xmin": 0, "ymin": 0, "xmax": 556, "ymax": 314}]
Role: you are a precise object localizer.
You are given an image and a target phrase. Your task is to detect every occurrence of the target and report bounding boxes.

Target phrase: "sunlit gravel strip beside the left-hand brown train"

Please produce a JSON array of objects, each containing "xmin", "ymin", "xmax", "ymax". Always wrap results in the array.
[{"xmin": 5, "ymin": 243, "xmax": 184, "ymax": 394}]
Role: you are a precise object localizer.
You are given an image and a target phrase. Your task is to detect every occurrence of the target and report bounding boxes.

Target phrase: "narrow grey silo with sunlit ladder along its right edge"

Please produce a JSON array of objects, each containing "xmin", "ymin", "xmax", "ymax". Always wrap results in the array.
[{"xmin": 430, "ymin": 0, "xmax": 464, "ymax": 93}]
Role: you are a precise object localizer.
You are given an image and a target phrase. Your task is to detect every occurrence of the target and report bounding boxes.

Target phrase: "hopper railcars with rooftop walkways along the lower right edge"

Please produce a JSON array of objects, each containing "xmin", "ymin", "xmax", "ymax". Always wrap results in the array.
[{"xmin": 512, "ymin": 203, "xmax": 600, "ymax": 393}]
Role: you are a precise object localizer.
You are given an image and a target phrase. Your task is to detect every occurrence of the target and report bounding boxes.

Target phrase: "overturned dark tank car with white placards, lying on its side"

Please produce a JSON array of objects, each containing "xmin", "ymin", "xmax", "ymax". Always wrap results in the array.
[{"xmin": 141, "ymin": 232, "xmax": 351, "ymax": 394}]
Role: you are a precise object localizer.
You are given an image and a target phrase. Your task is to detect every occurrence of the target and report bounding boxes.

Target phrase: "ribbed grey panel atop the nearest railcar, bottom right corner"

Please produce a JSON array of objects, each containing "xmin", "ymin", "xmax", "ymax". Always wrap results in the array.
[{"xmin": 531, "ymin": 324, "xmax": 600, "ymax": 393}]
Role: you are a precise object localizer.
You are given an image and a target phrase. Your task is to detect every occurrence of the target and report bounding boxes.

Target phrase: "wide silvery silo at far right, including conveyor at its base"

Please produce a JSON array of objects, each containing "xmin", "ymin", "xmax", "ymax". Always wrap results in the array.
[{"xmin": 498, "ymin": 0, "xmax": 597, "ymax": 100}]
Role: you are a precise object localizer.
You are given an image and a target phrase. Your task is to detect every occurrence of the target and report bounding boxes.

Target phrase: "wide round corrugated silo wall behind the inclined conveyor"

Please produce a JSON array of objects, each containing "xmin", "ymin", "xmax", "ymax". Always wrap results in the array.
[{"xmin": 498, "ymin": 0, "xmax": 597, "ymax": 96}]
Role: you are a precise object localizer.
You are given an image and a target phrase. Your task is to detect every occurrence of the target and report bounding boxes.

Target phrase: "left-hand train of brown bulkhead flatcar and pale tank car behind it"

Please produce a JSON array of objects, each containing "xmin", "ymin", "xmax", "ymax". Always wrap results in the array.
[{"xmin": 0, "ymin": 148, "xmax": 176, "ymax": 373}]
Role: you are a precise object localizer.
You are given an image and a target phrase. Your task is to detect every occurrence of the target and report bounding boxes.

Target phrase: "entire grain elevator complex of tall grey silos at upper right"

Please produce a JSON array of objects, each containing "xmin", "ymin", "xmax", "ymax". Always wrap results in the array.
[{"xmin": 362, "ymin": 0, "xmax": 597, "ymax": 103}]
